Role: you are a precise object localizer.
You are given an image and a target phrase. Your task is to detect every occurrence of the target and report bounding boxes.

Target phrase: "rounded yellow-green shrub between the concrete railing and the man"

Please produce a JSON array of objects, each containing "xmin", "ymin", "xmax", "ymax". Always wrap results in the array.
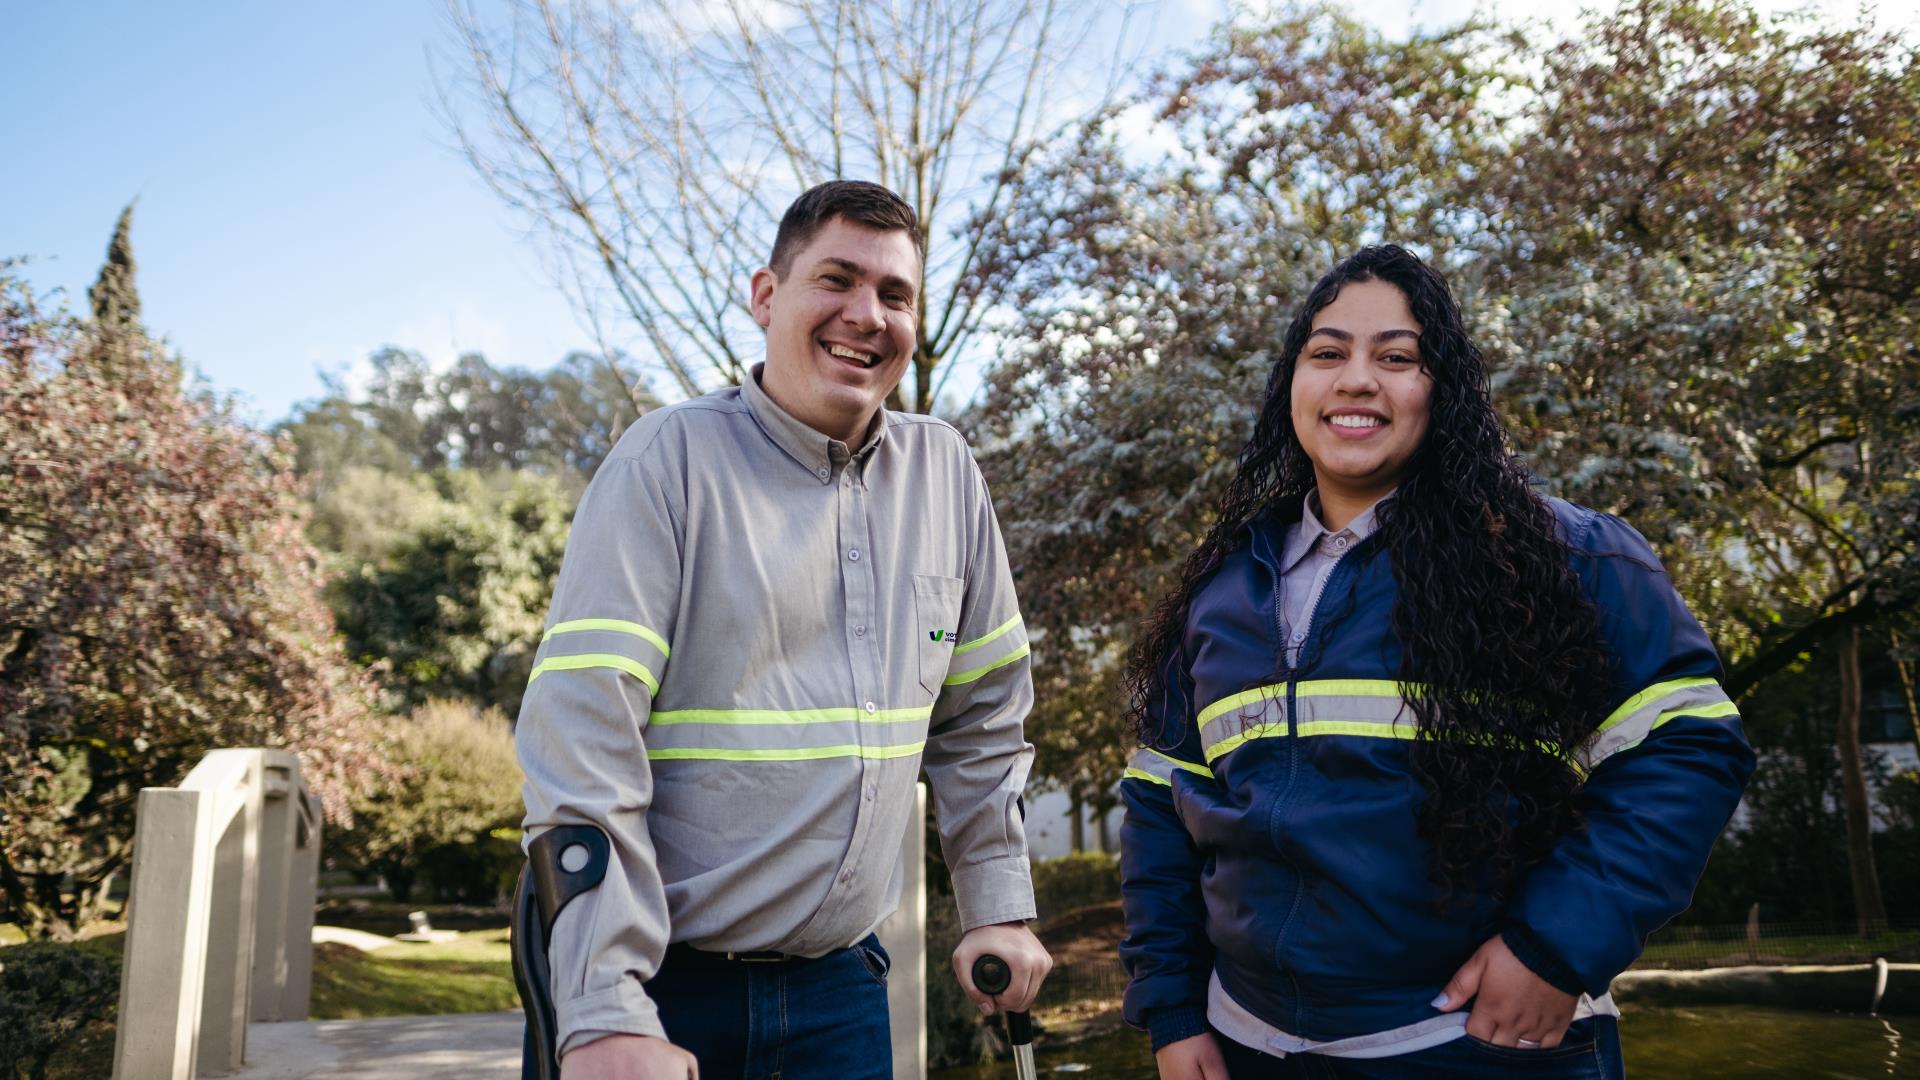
[{"xmin": 338, "ymin": 701, "xmax": 524, "ymax": 903}]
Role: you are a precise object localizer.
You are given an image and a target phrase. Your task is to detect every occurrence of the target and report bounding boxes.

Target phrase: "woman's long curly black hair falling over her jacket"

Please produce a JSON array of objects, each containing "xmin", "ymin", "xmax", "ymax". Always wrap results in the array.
[{"xmin": 1127, "ymin": 244, "xmax": 1607, "ymax": 897}]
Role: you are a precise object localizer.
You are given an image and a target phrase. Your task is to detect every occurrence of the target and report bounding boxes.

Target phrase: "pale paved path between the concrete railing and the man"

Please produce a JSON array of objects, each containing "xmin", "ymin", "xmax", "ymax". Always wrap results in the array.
[{"xmin": 234, "ymin": 1013, "xmax": 522, "ymax": 1080}]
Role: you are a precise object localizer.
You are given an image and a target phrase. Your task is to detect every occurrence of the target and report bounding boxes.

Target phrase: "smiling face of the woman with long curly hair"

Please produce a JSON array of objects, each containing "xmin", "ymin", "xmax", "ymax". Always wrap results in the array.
[{"xmin": 1292, "ymin": 281, "xmax": 1432, "ymax": 503}]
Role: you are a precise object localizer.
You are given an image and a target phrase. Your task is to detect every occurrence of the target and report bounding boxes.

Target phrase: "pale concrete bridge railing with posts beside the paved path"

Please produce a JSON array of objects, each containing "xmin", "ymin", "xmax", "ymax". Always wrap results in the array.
[{"xmin": 113, "ymin": 749, "xmax": 321, "ymax": 1080}]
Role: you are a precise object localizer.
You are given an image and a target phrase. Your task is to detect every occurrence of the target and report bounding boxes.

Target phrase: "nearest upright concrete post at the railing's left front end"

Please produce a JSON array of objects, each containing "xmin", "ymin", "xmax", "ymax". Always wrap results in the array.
[{"xmin": 113, "ymin": 788, "xmax": 215, "ymax": 1080}]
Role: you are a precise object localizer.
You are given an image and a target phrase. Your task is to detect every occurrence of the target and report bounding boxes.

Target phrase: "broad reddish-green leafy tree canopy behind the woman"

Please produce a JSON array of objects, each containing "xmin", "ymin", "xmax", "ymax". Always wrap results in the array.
[{"xmin": 968, "ymin": 0, "xmax": 1920, "ymax": 822}]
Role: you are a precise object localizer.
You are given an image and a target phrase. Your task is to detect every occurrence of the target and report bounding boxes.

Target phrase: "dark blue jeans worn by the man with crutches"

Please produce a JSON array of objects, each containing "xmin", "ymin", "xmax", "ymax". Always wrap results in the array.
[{"xmin": 526, "ymin": 934, "xmax": 893, "ymax": 1080}]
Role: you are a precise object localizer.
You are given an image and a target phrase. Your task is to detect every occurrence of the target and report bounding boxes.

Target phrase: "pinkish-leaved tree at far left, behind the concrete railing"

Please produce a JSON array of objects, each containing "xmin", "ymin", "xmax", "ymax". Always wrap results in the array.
[{"xmin": 0, "ymin": 215, "xmax": 382, "ymax": 938}]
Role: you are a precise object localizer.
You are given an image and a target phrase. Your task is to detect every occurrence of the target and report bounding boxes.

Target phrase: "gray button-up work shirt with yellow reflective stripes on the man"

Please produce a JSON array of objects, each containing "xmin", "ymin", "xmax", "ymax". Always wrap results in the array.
[{"xmin": 516, "ymin": 367, "xmax": 1033, "ymax": 1049}]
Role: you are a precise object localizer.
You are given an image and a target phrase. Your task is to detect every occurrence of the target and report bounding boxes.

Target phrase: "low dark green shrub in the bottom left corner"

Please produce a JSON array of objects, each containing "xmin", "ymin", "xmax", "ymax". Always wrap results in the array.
[{"xmin": 0, "ymin": 942, "xmax": 119, "ymax": 1080}]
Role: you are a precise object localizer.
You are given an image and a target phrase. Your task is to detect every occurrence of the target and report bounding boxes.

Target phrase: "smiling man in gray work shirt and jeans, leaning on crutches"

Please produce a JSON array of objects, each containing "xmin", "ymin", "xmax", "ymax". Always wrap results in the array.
[{"xmin": 516, "ymin": 181, "xmax": 1050, "ymax": 1080}]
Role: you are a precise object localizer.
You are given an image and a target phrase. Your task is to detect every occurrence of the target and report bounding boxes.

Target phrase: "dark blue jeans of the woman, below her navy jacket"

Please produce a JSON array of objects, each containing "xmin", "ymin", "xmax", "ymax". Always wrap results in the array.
[{"xmin": 1213, "ymin": 1017, "xmax": 1626, "ymax": 1080}]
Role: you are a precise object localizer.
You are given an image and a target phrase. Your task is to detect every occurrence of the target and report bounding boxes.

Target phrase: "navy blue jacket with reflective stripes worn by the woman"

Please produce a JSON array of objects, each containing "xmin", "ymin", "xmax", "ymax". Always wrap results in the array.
[{"xmin": 1121, "ymin": 500, "xmax": 1753, "ymax": 1040}]
